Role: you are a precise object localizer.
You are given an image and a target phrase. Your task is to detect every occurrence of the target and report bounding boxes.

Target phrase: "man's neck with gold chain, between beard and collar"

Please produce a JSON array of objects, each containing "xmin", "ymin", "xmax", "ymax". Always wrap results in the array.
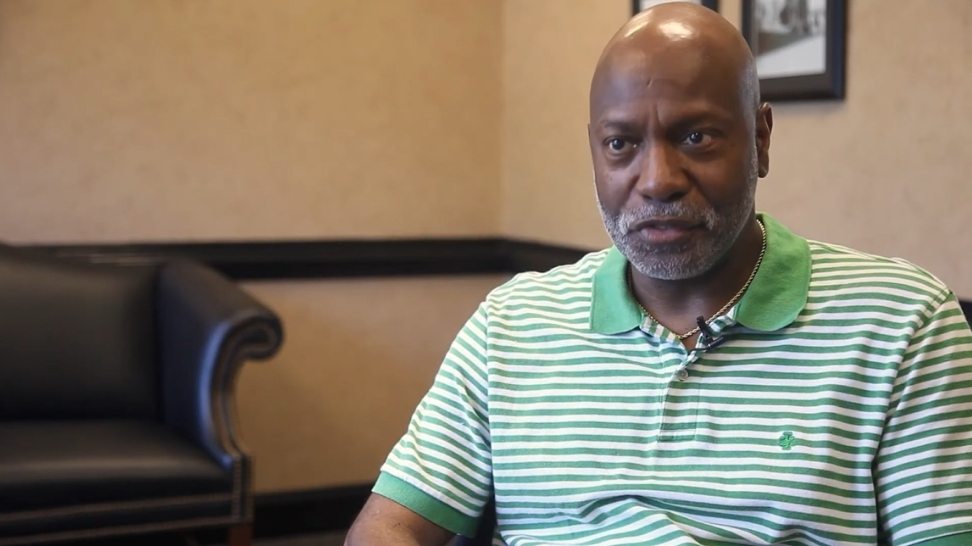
[{"xmin": 629, "ymin": 216, "xmax": 763, "ymax": 333}]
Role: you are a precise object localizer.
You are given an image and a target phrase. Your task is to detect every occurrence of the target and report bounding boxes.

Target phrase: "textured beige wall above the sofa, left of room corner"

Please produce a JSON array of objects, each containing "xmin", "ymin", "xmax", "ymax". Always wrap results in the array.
[{"xmin": 0, "ymin": 0, "xmax": 501, "ymax": 242}]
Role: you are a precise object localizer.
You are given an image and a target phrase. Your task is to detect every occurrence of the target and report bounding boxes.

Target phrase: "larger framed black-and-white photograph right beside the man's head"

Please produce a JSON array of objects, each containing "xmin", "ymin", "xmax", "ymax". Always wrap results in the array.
[{"xmin": 742, "ymin": 0, "xmax": 847, "ymax": 101}]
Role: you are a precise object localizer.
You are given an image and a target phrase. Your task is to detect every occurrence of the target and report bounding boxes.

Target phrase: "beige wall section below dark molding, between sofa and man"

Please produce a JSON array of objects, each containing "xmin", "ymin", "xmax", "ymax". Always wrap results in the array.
[{"xmin": 237, "ymin": 276, "xmax": 506, "ymax": 491}]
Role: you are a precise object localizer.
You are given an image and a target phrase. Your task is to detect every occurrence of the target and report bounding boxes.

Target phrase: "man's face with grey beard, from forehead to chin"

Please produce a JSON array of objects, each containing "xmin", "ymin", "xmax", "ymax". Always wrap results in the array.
[{"xmin": 589, "ymin": 39, "xmax": 768, "ymax": 280}]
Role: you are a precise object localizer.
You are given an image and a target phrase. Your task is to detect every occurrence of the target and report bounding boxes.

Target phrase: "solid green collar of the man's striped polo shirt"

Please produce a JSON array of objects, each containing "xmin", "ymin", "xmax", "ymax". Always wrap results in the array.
[{"xmin": 590, "ymin": 213, "xmax": 810, "ymax": 334}]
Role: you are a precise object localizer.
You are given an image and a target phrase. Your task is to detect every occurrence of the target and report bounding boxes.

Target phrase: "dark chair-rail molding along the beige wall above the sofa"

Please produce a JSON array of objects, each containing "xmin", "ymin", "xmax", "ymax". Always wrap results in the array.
[{"xmin": 22, "ymin": 237, "xmax": 972, "ymax": 322}]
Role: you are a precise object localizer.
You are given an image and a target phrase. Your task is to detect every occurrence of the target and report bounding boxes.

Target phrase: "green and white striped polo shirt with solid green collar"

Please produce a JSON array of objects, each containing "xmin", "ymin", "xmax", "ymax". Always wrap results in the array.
[{"xmin": 375, "ymin": 215, "xmax": 972, "ymax": 546}]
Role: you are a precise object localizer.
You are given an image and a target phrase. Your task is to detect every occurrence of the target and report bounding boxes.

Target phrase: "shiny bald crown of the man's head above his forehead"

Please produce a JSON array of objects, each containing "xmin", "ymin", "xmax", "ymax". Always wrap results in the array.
[{"xmin": 591, "ymin": 2, "xmax": 759, "ymax": 120}]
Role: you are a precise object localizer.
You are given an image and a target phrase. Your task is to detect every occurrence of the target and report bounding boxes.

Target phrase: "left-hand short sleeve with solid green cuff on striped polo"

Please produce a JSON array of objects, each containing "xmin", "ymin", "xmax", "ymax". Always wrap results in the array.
[{"xmin": 374, "ymin": 305, "xmax": 492, "ymax": 535}]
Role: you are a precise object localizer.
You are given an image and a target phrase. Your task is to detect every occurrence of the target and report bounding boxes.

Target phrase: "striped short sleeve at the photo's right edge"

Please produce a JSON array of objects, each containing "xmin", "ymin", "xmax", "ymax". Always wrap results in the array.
[{"xmin": 874, "ymin": 292, "xmax": 972, "ymax": 546}]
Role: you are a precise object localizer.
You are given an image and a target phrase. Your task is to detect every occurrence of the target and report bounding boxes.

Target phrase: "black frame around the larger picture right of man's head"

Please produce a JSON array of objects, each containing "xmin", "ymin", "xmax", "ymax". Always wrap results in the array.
[{"xmin": 742, "ymin": 0, "xmax": 847, "ymax": 102}]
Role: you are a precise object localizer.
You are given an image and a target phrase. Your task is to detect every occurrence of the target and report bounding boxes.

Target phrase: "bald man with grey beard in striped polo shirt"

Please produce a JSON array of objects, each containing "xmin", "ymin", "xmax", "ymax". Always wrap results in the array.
[{"xmin": 347, "ymin": 4, "xmax": 972, "ymax": 546}]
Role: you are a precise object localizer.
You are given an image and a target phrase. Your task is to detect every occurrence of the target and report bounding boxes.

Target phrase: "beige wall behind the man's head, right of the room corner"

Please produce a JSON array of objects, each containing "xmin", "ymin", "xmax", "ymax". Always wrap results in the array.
[{"xmin": 501, "ymin": 0, "xmax": 972, "ymax": 298}]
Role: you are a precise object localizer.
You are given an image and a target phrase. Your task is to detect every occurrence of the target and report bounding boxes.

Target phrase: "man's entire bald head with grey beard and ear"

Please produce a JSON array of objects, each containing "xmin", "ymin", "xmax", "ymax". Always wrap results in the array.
[{"xmin": 588, "ymin": 3, "xmax": 773, "ymax": 282}]
